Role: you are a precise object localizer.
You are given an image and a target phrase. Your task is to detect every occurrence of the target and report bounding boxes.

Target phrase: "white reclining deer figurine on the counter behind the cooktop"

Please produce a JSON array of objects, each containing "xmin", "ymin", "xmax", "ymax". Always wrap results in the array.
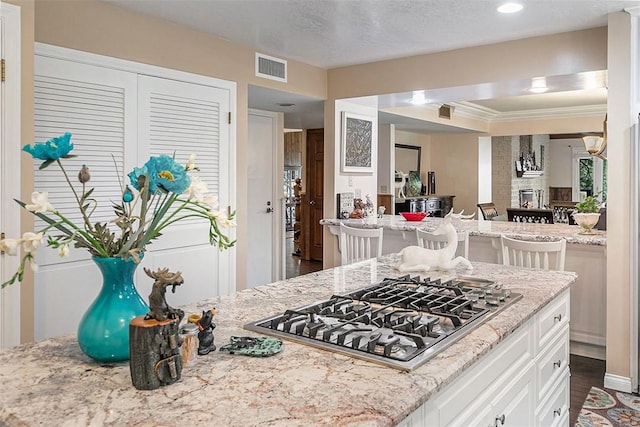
[{"xmin": 396, "ymin": 209, "xmax": 473, "ymax": 273}]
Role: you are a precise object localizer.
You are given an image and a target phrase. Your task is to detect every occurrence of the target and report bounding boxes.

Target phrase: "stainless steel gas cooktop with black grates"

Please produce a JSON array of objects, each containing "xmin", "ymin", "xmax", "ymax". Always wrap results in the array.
[{"xmin": 245, "ymin": 276, "xmax": 522, "ymax": 370}]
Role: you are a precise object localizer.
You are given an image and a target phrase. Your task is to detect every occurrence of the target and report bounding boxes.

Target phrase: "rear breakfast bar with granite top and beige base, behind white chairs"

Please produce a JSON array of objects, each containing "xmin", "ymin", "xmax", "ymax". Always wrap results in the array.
[{"xmin": 320, "ymin": 215, "xmax": 607, "ymax": 360}]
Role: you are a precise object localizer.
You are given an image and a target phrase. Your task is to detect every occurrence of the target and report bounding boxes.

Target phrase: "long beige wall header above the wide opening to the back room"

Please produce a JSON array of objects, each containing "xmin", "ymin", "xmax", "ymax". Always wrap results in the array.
[{"xmin": 328, "ymin": 27, "xmax": 607, "ymax": 99}]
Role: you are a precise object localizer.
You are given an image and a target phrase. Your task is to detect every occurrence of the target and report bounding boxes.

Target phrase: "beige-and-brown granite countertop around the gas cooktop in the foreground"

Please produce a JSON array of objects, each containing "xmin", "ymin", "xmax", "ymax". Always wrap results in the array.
[{"xmin": 0, "ymin": 255, "xmax": 575, "ymax": 426}]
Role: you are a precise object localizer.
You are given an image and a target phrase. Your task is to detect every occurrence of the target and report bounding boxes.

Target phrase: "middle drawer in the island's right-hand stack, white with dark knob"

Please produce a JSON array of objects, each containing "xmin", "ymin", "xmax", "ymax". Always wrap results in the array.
[{"xmin": 536, "ymin": 324, "xmax": 569, "ymax": 401}]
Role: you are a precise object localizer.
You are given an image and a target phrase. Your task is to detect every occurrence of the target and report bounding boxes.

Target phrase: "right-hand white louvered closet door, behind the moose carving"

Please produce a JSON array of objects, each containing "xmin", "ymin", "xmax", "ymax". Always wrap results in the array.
[{"xmin": 138, "ymin": 76, "xmax": 235, "ymax": 305}]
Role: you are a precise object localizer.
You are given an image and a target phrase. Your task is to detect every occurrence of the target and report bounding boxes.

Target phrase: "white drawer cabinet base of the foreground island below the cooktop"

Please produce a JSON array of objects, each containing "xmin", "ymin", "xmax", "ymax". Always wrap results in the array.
[{"xmin": 400, "ymin": 290, "xmax": 570, "ymax": 427}]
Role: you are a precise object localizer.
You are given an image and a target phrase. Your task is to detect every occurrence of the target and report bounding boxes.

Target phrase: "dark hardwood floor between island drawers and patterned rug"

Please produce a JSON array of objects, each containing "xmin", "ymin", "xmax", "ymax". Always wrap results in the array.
[{"xmin": 569, "ymin": 354, "xmax": 606, "ymax": 426}]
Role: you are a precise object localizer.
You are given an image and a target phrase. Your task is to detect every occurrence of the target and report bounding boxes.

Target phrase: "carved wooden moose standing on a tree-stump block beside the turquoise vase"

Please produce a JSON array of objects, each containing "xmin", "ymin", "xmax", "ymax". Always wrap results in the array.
[{"xmin": 129, "ymin": 268, "xmax": 184, "ymax": 390}]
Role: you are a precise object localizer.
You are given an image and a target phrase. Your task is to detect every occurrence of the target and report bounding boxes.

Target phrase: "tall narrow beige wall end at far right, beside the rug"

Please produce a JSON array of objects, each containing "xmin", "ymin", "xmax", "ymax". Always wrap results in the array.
[{"xmin": 605, "ymin": 12, "xmax": 638, "ymax": 385}]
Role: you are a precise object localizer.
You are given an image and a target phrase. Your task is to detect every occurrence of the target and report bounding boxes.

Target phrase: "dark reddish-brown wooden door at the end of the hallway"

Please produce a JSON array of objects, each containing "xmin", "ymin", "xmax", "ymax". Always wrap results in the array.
[{"xmin": 302, "ymin": 129, "xmax": 324, "ymax": 261}]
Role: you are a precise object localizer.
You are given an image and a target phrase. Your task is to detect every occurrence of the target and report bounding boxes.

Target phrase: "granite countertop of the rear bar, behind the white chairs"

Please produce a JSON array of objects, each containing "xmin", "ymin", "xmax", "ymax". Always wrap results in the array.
[{"xmin": 320, "ymin": 215, "xmax": 607, "ymax": 246}]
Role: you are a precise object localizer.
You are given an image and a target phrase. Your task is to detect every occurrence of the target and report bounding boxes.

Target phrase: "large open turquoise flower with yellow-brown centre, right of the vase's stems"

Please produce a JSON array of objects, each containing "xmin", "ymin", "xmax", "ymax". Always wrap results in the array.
[{"xmin": 129, "ymin": 154, "xmax": 191, "ymax": 194}]
